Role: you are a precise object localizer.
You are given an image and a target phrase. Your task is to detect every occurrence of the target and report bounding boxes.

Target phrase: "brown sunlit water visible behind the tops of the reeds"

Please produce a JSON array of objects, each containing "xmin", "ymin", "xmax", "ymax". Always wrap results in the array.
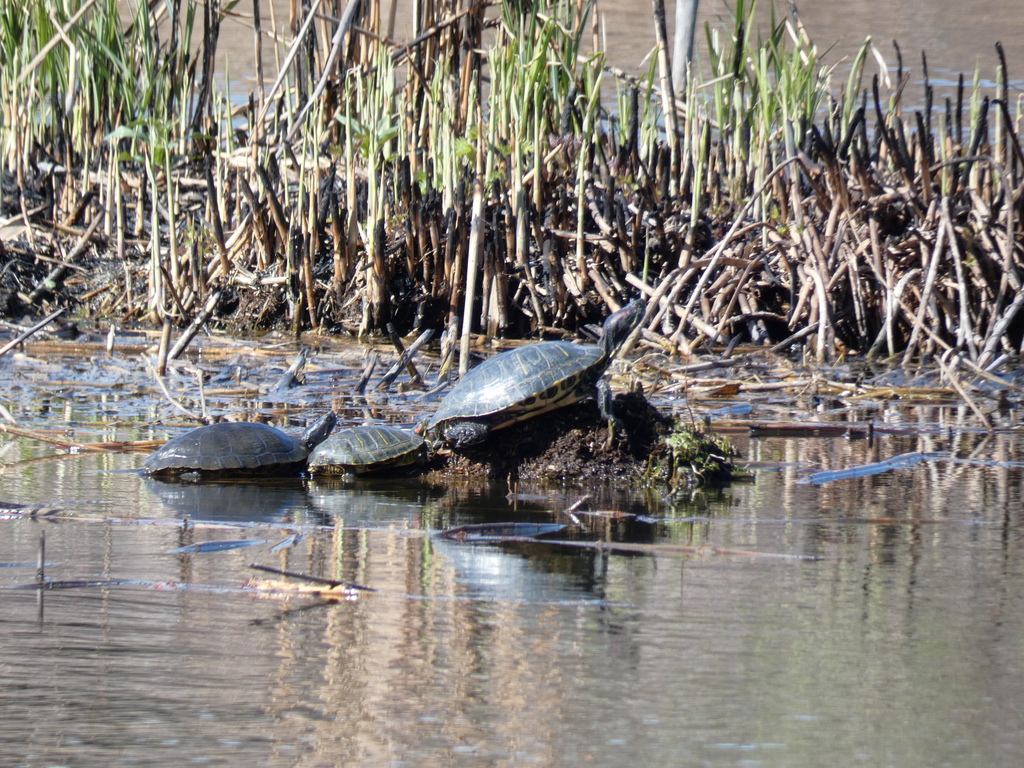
[{"xmin": 217, "ymin": 0, "xmax": 1024, "ymax": 102}]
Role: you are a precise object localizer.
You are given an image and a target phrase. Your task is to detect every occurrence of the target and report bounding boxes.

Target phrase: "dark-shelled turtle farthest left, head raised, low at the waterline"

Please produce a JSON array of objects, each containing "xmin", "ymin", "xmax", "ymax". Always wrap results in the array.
[{"xmin": 145, "ymin": 411, "xmax": 338, "ymax": 475}]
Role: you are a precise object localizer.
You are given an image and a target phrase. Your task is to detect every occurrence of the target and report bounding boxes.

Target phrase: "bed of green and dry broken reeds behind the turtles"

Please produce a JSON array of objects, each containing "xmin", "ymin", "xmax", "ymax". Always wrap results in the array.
[{"xmin": 0, "ymin": 0, "xmax": 1024, "ymax": 372}]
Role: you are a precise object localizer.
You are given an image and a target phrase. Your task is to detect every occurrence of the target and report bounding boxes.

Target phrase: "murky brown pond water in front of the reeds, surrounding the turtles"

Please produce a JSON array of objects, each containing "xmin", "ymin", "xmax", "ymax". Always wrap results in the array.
[{"xmin": 0, "ymin": 339, "xmax": 1024, "ymax": 768}]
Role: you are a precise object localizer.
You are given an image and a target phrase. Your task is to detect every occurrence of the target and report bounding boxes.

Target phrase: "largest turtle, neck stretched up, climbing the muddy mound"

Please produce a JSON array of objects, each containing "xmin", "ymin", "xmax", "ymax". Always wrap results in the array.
[{"xmin": 427, "ymin": 299, "xmax": 644, "ymax": 447}]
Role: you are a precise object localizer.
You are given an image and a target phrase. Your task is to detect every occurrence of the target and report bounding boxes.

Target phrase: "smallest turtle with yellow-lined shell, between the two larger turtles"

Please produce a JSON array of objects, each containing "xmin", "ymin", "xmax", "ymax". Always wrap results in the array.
[{"xmin": 309, "ymin": 426, "xmax": 427, "ymax": 475}]
